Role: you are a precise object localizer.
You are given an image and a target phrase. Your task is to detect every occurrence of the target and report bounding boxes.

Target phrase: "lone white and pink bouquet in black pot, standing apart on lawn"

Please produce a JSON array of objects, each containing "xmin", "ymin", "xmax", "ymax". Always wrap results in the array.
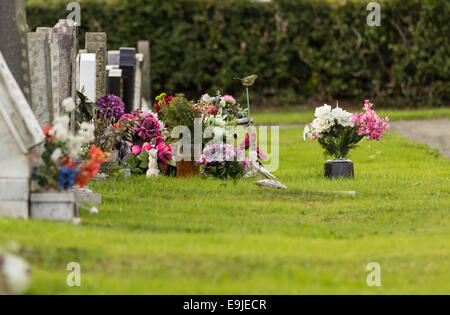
[{"xmin": 303, "ymin": 100, "xmax": 390, "ymax": 177}]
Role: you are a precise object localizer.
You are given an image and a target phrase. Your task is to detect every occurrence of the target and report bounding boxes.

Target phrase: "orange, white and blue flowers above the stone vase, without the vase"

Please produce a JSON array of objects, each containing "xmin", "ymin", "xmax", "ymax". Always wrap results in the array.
[{"xmin": 32, "ymin": 115, "xmax": 105, "ymax": 190}]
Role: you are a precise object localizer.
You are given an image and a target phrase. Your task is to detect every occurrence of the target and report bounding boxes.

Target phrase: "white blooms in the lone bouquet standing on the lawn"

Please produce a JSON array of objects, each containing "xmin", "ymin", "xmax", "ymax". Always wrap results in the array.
[{"xmin": 303, "ymin": 104, "xmax": 355, "ymax": 140}]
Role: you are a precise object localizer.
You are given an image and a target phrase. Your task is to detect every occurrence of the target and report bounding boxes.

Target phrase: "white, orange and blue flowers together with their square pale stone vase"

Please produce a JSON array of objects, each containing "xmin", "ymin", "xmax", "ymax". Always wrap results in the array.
[{"xmin": 31, "ymin": 116, "xmax": 105, "ymax": 221}]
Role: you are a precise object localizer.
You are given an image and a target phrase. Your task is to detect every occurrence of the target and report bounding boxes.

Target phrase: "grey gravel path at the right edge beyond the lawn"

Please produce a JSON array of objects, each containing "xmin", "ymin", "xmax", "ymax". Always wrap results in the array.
[{"xmin": 391, "ymin": 119, "xmax": 450, "ymax": 158}]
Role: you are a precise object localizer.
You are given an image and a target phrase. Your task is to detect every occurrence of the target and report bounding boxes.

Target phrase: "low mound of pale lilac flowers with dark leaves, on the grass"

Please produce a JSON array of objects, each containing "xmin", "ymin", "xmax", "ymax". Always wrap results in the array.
[{"xmin": 197, "ymin": 143, "xmax": 248, "ymax": 179}]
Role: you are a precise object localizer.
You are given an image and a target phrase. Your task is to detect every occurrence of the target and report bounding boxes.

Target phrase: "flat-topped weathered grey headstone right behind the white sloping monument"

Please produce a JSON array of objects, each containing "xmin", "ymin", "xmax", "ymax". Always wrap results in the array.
[{"xmin": 28, "ymin": 33, "xmax": 53, "ymax": 127}]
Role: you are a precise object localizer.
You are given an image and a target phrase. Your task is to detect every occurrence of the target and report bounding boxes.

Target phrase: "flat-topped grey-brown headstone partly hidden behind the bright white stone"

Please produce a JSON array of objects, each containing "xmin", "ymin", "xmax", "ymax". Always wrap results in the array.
[{"xmin": 86, "ymin": 32, "xmax": 107, "ymax": 102}]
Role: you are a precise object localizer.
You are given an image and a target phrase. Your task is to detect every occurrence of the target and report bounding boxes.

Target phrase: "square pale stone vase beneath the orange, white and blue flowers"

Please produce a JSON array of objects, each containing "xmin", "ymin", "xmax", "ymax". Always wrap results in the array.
[{"xmin": 31, "ymin": 191, "xmax": 77, "ymax": 222}]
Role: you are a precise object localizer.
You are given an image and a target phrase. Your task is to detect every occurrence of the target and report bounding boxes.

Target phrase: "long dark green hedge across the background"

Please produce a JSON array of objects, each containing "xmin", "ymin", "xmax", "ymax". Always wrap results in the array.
[{"xmin": 27, "ymin": 0, "xmax": 450, "ymax": 107}]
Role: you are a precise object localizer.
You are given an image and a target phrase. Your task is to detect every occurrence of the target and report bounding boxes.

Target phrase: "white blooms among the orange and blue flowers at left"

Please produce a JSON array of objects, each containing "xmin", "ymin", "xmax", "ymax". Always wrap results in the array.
[{"xmin": 49, "ymin": 115, "xmax": 95, "ymax": 162}]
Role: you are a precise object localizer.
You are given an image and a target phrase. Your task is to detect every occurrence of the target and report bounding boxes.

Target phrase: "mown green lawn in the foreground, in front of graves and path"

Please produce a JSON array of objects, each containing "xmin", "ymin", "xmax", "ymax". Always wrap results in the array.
[{"xmin": 0, "ymin": 114, "xmax": 450, "ymax": 294}]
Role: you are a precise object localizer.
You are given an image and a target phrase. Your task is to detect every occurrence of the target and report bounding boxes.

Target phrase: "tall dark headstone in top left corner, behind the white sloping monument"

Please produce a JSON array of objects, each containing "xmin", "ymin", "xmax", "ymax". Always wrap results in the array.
[{"xmin": 0, "ymin": 0, "xmax": 31, "ymax": 100}]
